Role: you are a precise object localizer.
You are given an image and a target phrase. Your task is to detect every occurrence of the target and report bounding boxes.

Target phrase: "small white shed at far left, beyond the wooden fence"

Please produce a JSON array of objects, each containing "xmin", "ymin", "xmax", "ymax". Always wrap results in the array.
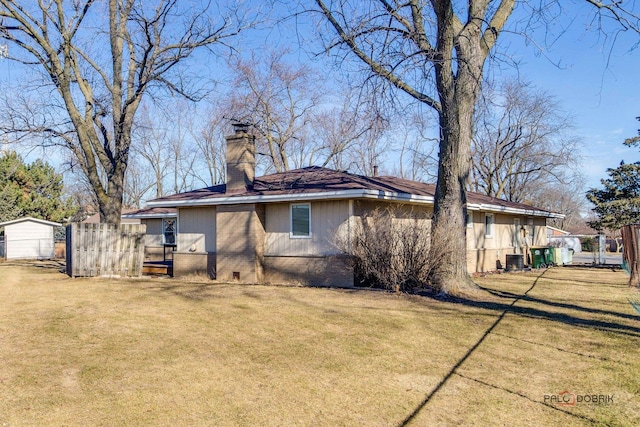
[{"xmin": 0, "ymin": 217, "xmax": 62, "ymax": 259}]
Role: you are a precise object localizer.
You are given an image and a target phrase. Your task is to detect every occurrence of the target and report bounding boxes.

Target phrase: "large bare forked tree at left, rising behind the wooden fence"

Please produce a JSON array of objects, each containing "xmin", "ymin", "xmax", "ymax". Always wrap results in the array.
[{"xmin": 0, "ymin": 0, "xmax": 252, "ymax": 223}]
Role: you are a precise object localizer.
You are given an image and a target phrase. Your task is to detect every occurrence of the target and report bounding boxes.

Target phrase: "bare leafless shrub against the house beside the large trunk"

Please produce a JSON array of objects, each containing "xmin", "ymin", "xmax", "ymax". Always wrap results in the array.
[{"xmin": 334, "ymin": 205, "xmax": 444, "ymax": 292}]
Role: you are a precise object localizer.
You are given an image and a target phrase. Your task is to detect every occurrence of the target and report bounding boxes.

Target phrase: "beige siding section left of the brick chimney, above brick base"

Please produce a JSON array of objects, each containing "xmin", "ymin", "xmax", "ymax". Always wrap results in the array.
[{"xmin": 177, "ymin": 206, "xmax": 216, "ymax": 253}]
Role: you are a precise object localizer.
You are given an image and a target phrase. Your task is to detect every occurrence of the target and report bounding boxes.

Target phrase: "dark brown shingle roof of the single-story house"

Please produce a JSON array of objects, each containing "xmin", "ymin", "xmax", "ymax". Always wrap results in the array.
[{"xmin": 149, "ymin": 166, "xmax": 554, "ymax": 216}]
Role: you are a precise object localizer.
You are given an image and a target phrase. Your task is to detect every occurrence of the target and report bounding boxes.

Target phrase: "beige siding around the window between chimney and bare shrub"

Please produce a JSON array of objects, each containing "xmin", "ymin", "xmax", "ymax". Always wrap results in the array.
[{"xmin": 265, "ymin": 200, "xmax": 349, "ymax": 256}]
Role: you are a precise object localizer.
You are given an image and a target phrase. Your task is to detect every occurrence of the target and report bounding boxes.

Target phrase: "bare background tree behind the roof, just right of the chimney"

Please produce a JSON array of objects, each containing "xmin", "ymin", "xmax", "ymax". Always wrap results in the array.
[{"xmin": 222, "ymin": 50, "xmax": 387, "ymax": 174}]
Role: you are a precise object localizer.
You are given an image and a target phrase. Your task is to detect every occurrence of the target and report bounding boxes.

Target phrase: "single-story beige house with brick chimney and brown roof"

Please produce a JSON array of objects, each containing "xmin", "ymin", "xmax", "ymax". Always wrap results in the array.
[{"xmin": 148, "ymin": 129, "xmax": 562, "ymax": 286}]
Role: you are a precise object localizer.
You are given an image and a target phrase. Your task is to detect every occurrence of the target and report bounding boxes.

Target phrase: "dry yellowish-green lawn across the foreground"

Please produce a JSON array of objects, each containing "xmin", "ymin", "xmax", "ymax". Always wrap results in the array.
[{"xmin": 0, "ymin": 263, "xmax": 640, "ymax": 427}]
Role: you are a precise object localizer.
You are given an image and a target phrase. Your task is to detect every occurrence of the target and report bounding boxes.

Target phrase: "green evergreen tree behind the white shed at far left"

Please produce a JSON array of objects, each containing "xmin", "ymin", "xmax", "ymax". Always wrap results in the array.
[{"xmin": 0, "ymin": 152, "xmax": 78, "ymax": 223}]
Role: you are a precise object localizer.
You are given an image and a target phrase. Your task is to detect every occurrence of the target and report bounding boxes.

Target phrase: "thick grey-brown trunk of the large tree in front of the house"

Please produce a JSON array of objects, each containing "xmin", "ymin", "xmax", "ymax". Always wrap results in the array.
[{"xmin": 431, "ymin": 2, "xmax": 486, "ymax": 294}]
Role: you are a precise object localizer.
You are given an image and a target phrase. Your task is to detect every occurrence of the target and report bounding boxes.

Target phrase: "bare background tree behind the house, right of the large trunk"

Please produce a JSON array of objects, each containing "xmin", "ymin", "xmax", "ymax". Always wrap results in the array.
[{"xmin": 470, "ymin": 82, "xmax": 580, "ymax": 202}]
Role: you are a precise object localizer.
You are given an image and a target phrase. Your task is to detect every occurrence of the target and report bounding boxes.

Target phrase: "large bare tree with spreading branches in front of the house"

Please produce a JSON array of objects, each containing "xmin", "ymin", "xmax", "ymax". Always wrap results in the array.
[{"xmin": 315, "ymin": 0, "xmax": 639, "ymax": 293}]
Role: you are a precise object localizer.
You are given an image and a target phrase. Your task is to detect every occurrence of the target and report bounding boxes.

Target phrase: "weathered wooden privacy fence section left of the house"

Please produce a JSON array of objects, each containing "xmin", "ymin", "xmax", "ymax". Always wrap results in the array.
[{"xmin": 66, "ymin": 223, "xmax": 147, "ymax": 277}]
